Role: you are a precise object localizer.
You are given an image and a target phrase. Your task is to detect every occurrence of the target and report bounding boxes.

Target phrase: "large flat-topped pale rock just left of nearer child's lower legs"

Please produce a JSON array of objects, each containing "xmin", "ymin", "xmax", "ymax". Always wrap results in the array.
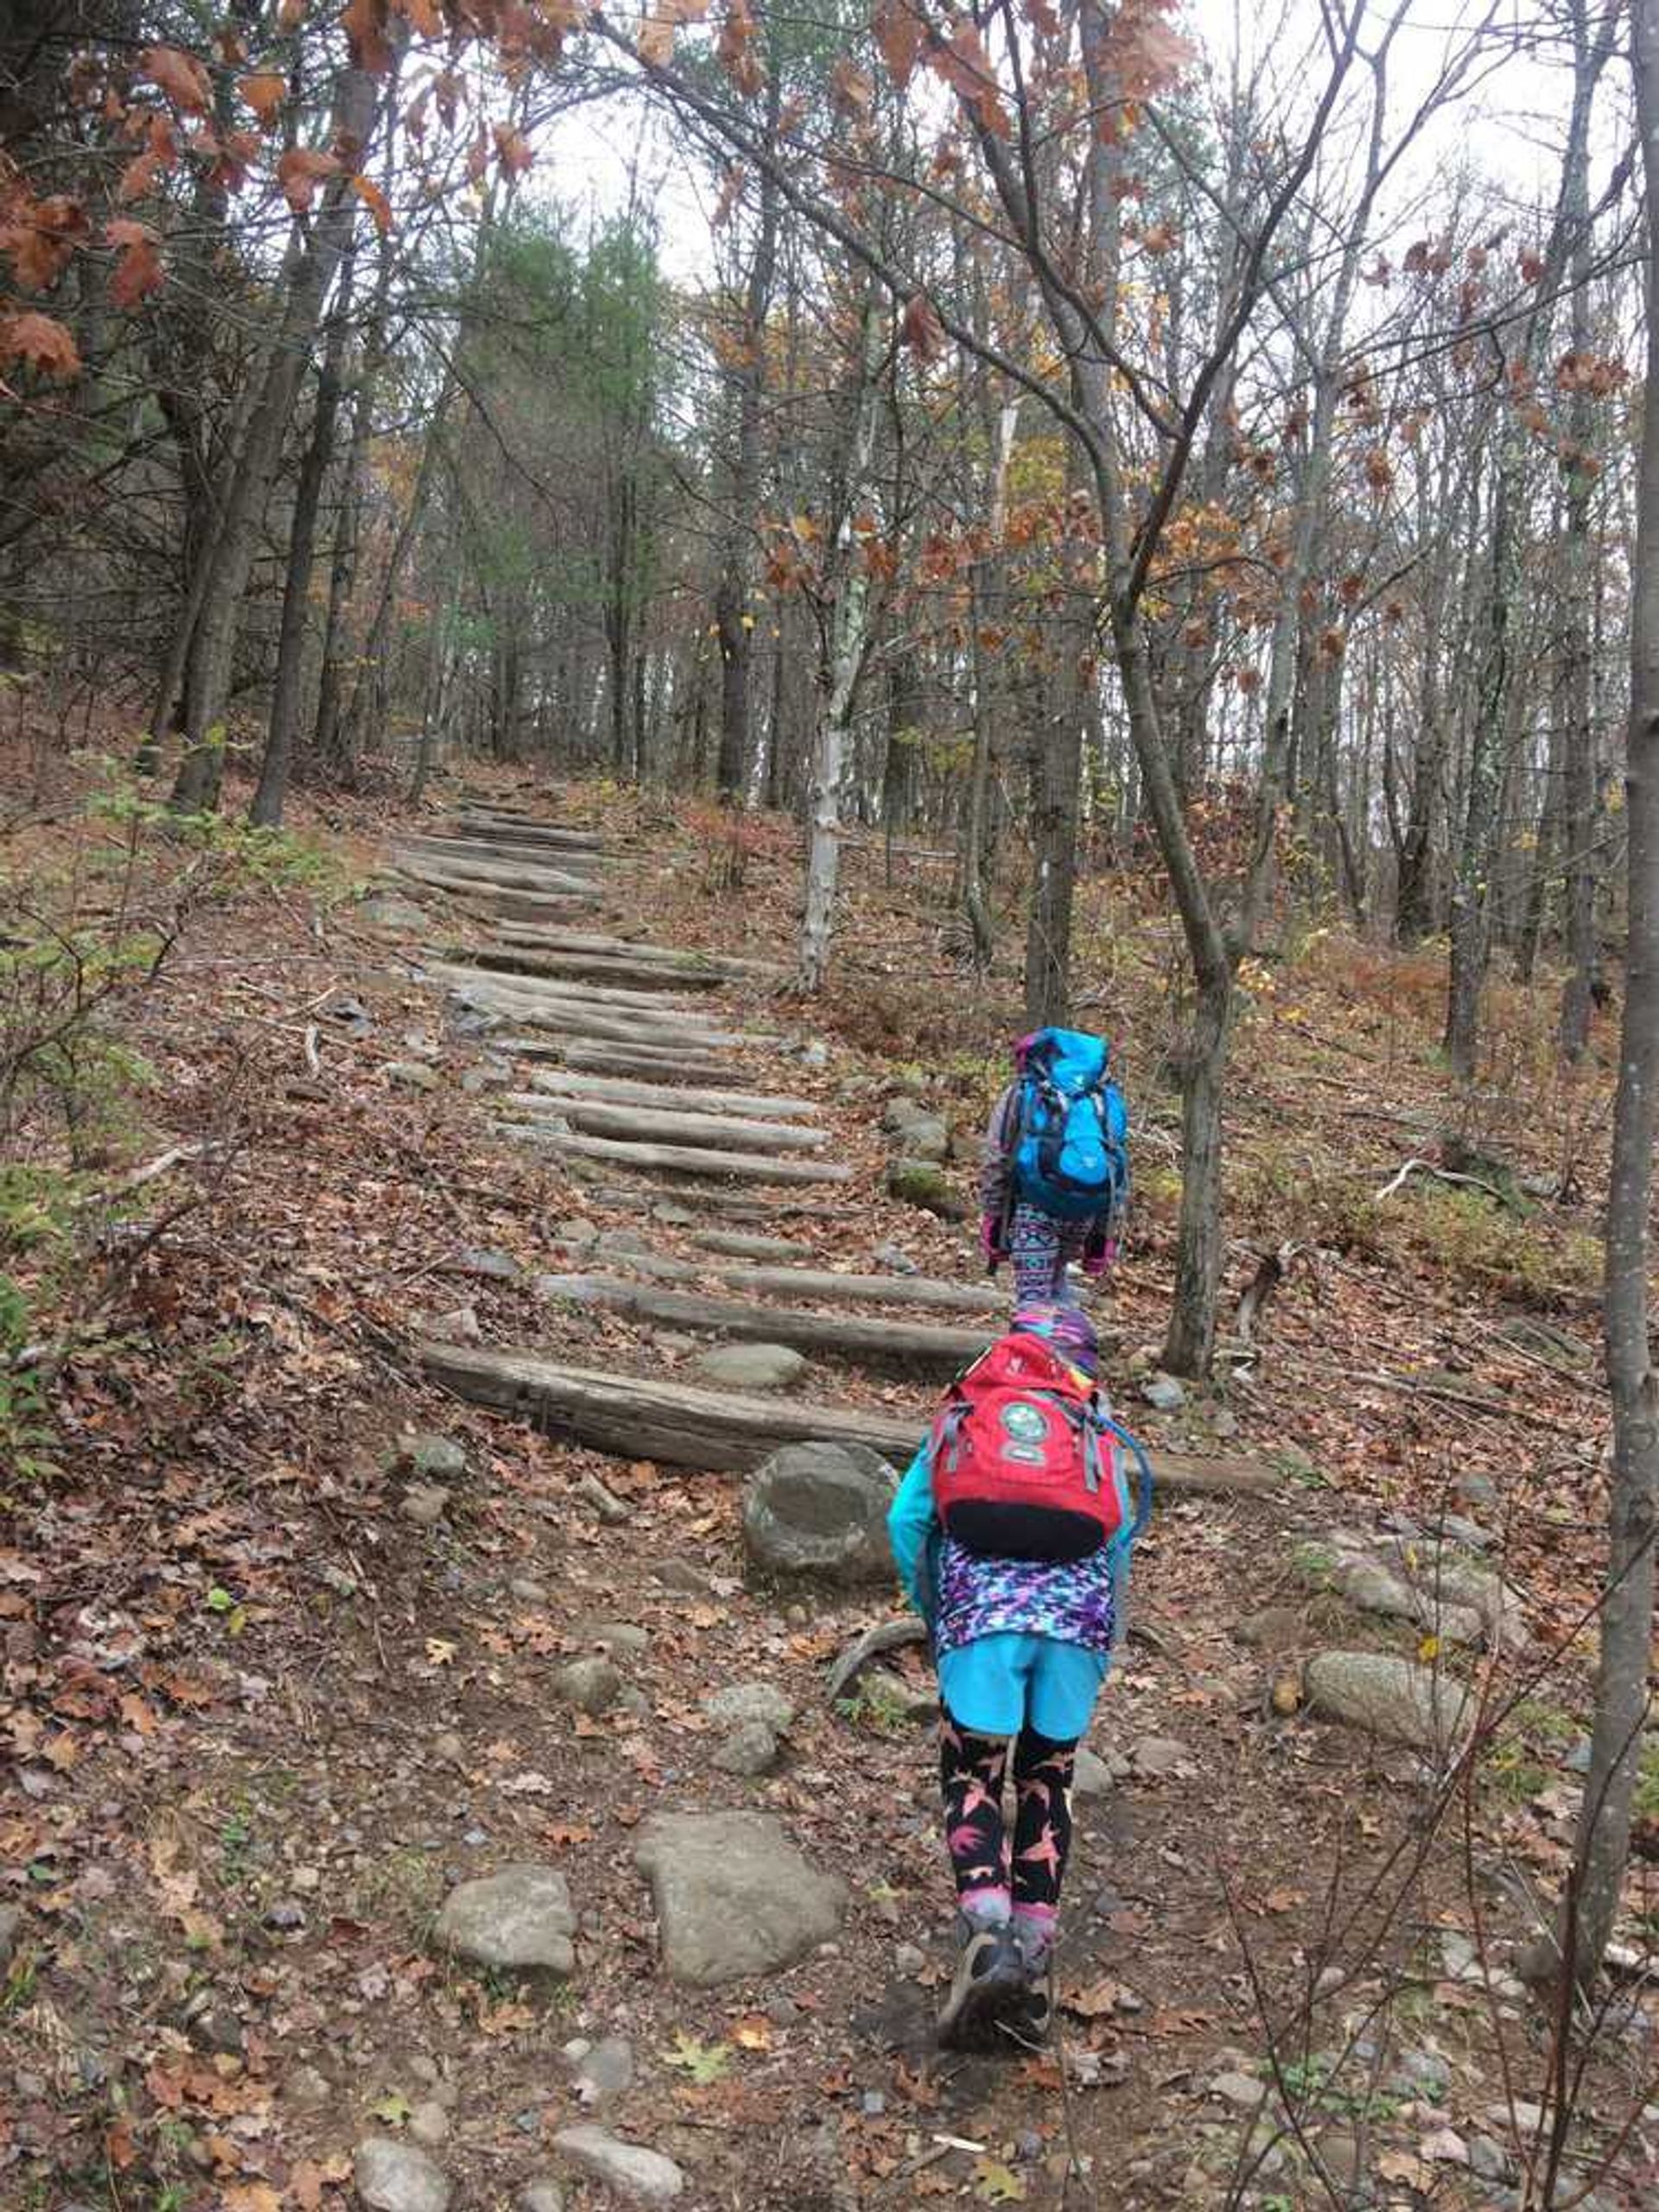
[{"xmin": 632, "ymin": 1812, "xmax": 847, "ymax": 1988}]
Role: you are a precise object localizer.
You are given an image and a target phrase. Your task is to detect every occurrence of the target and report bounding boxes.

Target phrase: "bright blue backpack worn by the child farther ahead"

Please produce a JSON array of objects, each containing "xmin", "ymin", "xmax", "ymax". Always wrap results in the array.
[{"xmin": 1008, "ymin": 1028, "xmax": 1128, "ymax": 1228}]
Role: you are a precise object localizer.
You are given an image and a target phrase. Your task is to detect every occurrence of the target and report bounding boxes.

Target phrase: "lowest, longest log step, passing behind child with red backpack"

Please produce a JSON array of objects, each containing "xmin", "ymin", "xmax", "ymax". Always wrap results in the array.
[{"xmin": 416, "ymin": 1343, "xmax": 1279, "ymax": 1497}]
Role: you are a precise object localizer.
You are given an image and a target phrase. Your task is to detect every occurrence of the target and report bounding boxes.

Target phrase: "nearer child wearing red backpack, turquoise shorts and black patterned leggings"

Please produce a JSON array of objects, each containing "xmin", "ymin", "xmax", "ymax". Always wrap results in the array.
[{"xmin": 887, "ymin": 1305, "xmax": 1150, "ymax": 2049}]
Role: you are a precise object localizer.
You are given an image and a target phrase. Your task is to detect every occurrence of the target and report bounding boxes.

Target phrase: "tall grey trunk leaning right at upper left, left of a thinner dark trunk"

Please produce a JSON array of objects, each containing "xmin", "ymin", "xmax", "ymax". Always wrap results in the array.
[{"xmin": 170, "ymin": 67, "xmax": 380, "ymax": 812}]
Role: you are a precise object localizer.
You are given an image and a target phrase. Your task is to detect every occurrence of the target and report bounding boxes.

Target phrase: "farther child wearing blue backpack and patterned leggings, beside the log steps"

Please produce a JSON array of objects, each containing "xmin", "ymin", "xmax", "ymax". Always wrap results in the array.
[{"xmin": 980, "ymin": 1028, "xmax": 1128, "ymax": 1305}]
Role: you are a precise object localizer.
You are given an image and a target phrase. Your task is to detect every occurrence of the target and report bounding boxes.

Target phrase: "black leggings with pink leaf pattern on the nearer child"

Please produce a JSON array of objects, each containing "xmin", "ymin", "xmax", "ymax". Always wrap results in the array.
[{"xmin": 938, "ymin": 1714, "xmax": 1077, "ymax": 1927}]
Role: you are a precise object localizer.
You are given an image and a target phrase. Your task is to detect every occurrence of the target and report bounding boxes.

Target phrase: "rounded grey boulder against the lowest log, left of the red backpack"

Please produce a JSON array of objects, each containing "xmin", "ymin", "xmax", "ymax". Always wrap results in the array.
[{"xmin": 743, "ymin": 1445, "xmax": 898, "ymax": 1591}]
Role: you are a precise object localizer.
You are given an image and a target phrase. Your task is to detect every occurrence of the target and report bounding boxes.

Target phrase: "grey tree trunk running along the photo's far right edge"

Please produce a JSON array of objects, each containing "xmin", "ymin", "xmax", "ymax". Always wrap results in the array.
[{"xmin": 1571, "ymin": 0, "xmax": 1659, "ymax": 1982}]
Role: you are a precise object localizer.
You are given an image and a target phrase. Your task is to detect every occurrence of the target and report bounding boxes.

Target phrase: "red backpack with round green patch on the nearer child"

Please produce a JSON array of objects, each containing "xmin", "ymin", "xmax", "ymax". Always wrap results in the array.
[{"xmin": 929, "ymin": 1332, "xmax": 1133, "ymax": 1561}]
